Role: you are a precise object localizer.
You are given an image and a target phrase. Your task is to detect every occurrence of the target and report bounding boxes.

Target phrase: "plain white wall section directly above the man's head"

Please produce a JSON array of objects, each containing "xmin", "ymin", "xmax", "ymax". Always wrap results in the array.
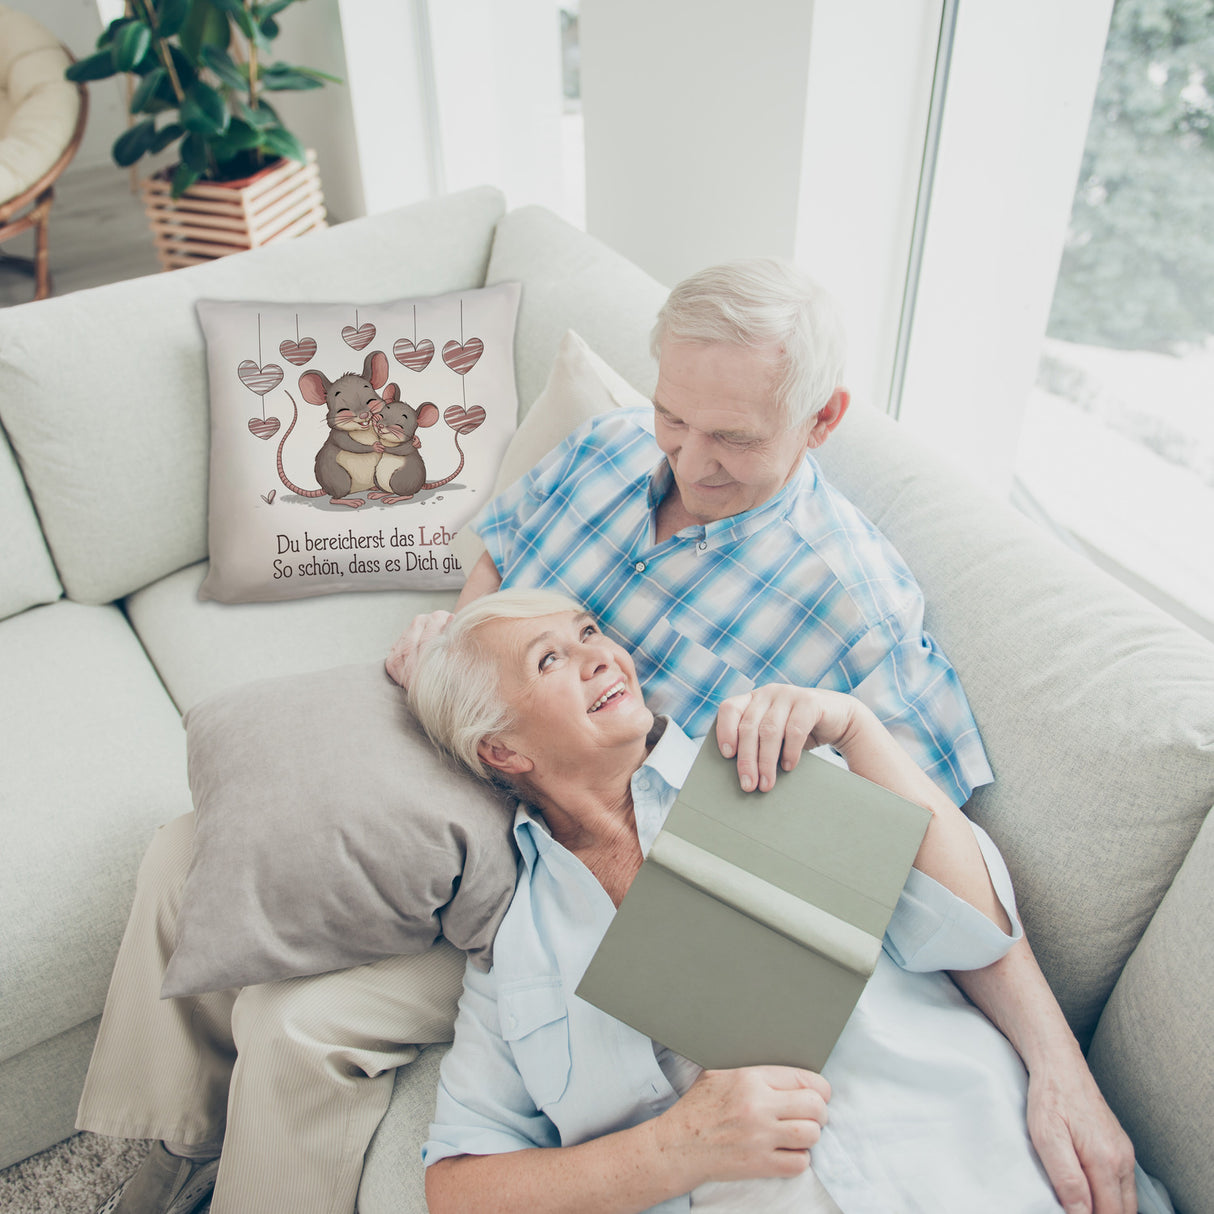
[{"xmin": 580, "ymin": 0, "xmax": 813, "ymax": 283}]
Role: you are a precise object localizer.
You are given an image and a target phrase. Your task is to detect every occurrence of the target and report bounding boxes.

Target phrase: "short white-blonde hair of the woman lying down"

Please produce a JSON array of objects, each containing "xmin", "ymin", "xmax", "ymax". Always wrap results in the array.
[{"xmin": 409, "ymin": 590, "xmax": 583, "ymax": 779}]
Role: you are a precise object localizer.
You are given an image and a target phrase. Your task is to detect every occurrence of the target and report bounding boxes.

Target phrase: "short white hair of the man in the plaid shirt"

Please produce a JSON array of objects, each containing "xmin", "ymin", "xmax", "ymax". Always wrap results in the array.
[{"xmin": 649, "ymin": 257, "xmax": 846, "ymax": 427}]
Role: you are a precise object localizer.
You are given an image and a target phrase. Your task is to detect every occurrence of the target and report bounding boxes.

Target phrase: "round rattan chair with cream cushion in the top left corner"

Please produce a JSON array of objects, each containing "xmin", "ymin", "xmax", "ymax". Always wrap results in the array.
[{"xmin": 0, "ymin": 5, "xmax": 89, "ymax": 300}]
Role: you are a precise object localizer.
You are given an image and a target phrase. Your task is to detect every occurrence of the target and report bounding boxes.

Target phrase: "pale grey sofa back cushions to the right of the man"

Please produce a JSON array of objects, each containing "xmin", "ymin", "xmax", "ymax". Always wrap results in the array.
[{"xmin": 819, "ymin": 408, "xmax": 1214, "ymax": 1209}]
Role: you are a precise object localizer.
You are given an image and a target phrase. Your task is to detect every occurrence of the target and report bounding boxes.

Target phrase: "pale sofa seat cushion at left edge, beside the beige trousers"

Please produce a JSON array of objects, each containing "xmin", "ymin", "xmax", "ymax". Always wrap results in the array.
[{"xmin": 0, "ymin": 601, "xmax": 189, "ymax": 1057}]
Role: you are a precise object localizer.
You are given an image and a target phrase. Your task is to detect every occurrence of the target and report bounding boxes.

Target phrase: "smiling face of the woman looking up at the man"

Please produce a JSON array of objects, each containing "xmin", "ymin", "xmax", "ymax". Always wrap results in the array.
[{"xmin": 477, "ymin": 611, "xmax": 653, "ymax": 773}]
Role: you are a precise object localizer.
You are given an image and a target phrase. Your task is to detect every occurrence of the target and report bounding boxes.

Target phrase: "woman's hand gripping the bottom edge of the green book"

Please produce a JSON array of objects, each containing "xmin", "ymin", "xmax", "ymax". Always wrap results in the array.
[{"xmin": 654, "ymin": 1066, "xmax": 830, "ymax": 1189}]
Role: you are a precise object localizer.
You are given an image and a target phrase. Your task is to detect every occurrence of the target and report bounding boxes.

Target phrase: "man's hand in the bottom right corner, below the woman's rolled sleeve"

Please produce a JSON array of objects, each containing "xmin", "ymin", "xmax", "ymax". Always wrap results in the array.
[{"xmin": 1028, "ymin": 1060, "xmax": 1138, "ymax": 1214}]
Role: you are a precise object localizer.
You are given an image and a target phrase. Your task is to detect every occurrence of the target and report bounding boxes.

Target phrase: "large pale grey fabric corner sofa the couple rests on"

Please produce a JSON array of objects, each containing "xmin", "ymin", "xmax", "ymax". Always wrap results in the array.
[{"xmin": 0, "ymin": 188, "xmax": 1214, "ymax": 1214}]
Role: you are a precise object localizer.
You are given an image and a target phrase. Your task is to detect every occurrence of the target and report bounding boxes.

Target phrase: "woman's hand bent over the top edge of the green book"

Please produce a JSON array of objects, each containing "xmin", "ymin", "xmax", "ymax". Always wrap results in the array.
[{"xmin": 716, "ymin": 683, "xmax": 868, "ymax": 793}]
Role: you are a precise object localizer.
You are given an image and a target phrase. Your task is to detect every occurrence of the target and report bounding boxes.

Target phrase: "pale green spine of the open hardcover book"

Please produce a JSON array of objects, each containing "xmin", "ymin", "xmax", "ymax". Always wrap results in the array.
[{"xmin": 648, "ymin": 830, "xmax": 881, "ymax": 978}]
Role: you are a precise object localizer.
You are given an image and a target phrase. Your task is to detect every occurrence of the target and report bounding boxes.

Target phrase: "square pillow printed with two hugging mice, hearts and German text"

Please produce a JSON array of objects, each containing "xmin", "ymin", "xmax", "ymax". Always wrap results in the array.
[{"xmin": 197, "ymin": 283, "xmax": 521, "ymax": 602}]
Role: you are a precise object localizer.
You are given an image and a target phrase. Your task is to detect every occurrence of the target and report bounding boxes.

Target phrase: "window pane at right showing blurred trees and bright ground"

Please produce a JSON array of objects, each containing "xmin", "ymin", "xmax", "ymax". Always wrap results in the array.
[{"xmin": 1016, "ymin": 0, "xmax": 1214, "ymax": 635}]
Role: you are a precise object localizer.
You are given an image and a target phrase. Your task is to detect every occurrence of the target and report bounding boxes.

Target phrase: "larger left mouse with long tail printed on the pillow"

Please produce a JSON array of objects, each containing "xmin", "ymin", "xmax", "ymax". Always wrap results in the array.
[{"xmin": 278, "ymin": 350, "xmax": 388, "ymax": 509}]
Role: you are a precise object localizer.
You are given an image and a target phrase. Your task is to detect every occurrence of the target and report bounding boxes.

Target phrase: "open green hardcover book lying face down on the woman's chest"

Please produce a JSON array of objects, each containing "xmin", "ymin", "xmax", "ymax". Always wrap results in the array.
[{"xmin": 577, "ymin": 734, "xmax": 931, "ymax": 1071}]
